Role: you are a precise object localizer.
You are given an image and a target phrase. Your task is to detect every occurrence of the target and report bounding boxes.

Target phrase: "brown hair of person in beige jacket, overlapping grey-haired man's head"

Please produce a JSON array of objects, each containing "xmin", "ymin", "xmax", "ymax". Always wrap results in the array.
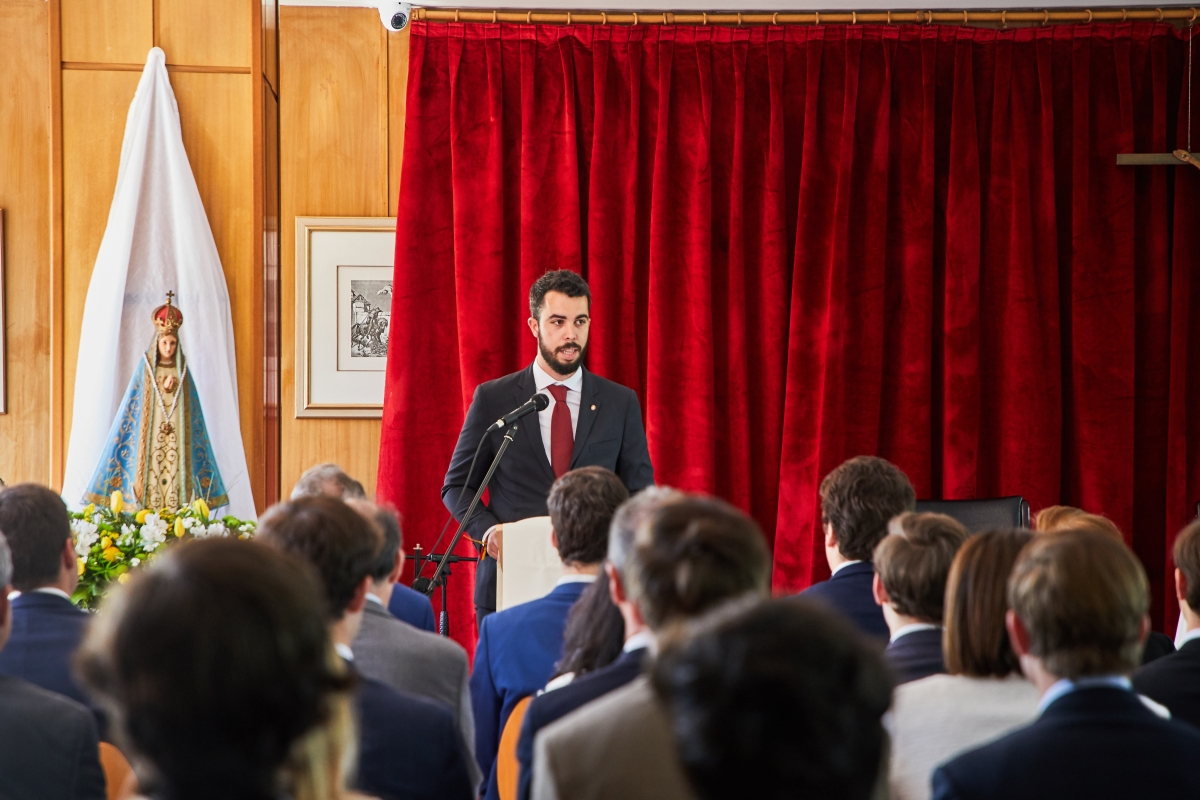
[{"xmin": 626, "ymin": 494, "xmax": 770, "ymax": 631}]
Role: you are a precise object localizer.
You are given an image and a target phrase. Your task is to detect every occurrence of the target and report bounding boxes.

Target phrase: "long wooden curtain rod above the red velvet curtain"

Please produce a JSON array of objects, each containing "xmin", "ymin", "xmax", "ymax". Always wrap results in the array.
[{"xmin": 413, "ymin": 7, "xmax": 1198, "ymax": 28}]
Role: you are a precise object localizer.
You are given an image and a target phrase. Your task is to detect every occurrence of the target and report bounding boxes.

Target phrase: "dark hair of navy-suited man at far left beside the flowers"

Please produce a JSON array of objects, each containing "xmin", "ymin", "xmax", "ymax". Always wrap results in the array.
[{"xmin": 0, "ymin": 483, "xmax": 71, "ymax": 591}]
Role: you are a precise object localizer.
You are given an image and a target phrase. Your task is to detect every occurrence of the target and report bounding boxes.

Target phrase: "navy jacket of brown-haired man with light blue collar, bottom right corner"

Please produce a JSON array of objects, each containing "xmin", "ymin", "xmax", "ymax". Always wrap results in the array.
[{"xmin": 932, "ymin": 687, "xmax": 1200, "ymax": 800}]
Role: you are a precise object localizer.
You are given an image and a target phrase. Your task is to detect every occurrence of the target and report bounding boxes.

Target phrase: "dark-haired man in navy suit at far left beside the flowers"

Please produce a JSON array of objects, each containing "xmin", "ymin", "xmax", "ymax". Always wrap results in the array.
[{"xmin": 0, "ymin": 483, "xmax": 103, "ymax": 733}]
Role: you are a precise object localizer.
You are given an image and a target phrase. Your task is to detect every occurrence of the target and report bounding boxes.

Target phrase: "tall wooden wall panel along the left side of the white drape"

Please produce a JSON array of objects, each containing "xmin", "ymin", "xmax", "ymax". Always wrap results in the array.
[{"xmin": 60, "ymin": 70, "xmax": 142, "ymax": 455}]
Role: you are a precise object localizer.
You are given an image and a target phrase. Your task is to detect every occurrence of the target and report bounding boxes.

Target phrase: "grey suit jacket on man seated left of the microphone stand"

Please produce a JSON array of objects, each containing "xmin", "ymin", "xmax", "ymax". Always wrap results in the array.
[{"xmin": 350, "ymin": 597, "xmax": 484, "ymax": 787}]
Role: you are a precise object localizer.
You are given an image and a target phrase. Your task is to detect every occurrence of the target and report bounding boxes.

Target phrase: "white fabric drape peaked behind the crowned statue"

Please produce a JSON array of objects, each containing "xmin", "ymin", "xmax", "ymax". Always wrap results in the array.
[{"xmin": 62, "ymin": 47, "xmax": 256, "ymax": 519}]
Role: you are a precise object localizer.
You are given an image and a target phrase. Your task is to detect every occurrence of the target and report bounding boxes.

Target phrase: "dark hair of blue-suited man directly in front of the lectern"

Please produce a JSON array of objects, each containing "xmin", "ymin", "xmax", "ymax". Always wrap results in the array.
[{"xmin": 546, "ymin": 467, "xmax": 629, "ymax": 564}]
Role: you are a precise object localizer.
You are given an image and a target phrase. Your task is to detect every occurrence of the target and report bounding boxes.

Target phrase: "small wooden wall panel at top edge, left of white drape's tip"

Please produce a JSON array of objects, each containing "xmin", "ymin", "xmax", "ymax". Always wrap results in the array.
[{"xmin": 60, "ymin": 0, "xmax": 152, "ymax": 64}]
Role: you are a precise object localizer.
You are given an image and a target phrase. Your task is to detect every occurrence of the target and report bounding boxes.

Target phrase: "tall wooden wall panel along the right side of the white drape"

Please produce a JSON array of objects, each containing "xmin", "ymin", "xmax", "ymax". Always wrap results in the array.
[{"xmin": 170, "ymin": 72, "xmax": 264, "ymax": 506}]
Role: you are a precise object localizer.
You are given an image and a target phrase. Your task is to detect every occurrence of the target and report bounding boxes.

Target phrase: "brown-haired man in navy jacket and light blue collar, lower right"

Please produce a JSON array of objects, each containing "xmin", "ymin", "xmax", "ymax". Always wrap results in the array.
[{"xmin": 932, "ymin": 529, "xmax": 1200, "ymax": 800}]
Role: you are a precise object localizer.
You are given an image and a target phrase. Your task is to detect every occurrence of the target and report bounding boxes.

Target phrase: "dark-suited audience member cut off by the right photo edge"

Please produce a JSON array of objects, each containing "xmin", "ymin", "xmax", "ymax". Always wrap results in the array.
[{"xmin": 1133, "ymin": 522, "xmax": 1200, "ymax": 728}]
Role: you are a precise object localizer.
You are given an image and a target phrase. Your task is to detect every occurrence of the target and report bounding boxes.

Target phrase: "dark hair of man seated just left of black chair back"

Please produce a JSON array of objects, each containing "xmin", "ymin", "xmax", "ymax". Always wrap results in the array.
[{"xmin": 821, "ymin": 456, "xmax": 917, "ymax": 561}]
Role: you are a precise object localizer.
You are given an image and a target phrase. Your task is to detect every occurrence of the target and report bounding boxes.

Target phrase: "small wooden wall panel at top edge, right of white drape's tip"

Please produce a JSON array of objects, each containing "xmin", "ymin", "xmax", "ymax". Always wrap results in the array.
[{"xmin": 157, "ymin": 0, "xmax": 250, "ymax": 68}]
